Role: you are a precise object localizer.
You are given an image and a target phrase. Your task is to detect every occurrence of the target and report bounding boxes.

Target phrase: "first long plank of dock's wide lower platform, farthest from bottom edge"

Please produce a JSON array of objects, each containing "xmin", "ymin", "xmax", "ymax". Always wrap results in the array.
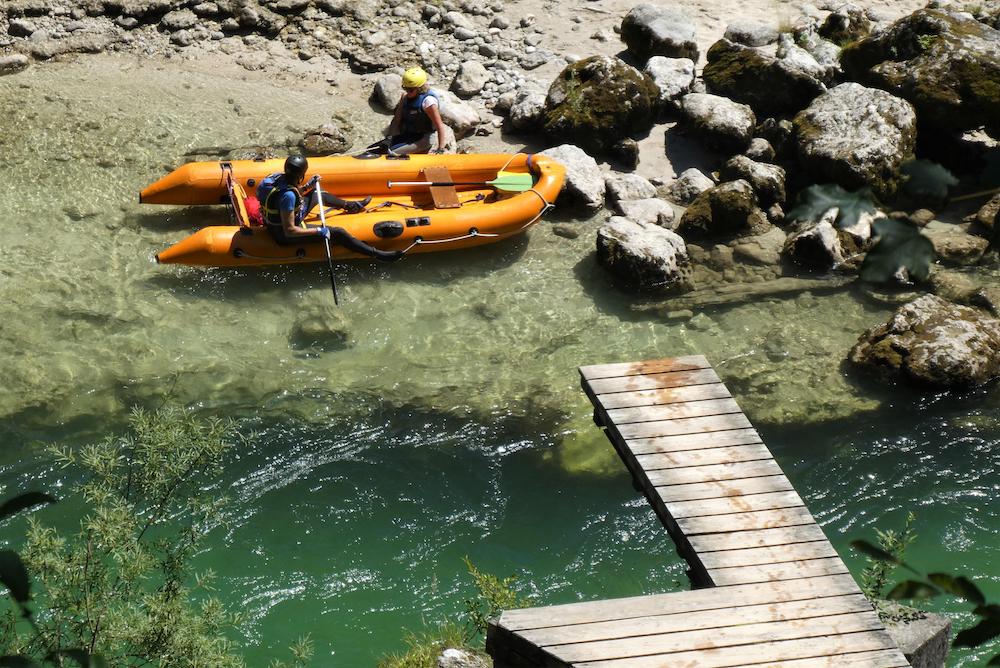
[{"xmin": 499, "ymin": 575, "xmax": 859, "ymax": 631}]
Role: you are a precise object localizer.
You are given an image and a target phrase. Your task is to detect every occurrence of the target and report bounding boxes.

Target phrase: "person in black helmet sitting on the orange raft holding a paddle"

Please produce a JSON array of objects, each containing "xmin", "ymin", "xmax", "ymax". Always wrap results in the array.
[{"xmin": 257, "ymin": 155, "xmax": 403, "ymax": 260}]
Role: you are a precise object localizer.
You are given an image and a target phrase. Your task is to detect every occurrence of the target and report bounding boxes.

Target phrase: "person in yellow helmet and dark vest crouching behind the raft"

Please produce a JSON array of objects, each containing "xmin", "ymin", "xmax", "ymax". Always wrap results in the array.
[{"xmin": 386, "ymin": 67, "xmax": 454, "ymax": 155}]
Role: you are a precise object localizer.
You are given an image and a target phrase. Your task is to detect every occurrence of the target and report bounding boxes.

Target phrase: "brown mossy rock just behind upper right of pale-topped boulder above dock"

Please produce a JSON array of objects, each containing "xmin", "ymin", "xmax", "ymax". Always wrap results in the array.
[{"xmin": 678, "ymin": 179, "xmax": 768, "ymax": 239}]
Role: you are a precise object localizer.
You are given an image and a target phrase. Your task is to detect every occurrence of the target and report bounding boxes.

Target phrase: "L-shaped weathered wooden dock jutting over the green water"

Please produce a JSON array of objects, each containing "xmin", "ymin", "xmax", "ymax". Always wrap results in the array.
[{"xmin": 486, "ymin": 355, "xmax": 910, "ymax": 668}]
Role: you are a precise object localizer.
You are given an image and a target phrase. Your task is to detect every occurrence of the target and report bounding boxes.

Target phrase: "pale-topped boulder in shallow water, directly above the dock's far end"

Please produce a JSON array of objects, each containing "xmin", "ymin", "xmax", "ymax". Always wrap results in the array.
[{"xmin": 597, "ymin": 216, "xmax": 690, "ymax": 294}]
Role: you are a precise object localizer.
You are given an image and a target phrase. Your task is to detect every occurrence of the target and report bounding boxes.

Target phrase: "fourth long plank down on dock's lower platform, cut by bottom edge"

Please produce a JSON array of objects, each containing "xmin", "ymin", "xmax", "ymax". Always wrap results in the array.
[{"xmin": 574, "ymin": 631, "xmax": 895, "ymax": 668}]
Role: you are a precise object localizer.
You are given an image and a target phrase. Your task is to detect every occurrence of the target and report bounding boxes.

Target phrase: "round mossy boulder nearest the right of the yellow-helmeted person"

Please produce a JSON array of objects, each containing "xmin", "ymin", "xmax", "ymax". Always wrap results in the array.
[{"xmin": 543, "ymin": 56, "xmax": 659, "ymax": 153}]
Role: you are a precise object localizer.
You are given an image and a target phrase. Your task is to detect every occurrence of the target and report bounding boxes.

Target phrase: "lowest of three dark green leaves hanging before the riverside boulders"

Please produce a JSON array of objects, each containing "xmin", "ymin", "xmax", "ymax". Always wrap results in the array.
[{"xmin": 860, "ymin": 218, "xmax": 935, "ymax": 283}]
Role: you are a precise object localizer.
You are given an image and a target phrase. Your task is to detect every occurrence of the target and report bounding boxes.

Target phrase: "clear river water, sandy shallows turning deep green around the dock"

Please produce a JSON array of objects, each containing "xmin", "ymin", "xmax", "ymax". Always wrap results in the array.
[{"xmin": 0, "ymin": 58, "xmax": 1000, "ymax": 666}]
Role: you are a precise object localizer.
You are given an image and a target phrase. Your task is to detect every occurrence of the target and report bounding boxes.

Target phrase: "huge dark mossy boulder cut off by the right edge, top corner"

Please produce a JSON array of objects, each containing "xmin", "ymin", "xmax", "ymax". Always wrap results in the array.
[{"xmin": 841, "ymin": 9, "xmax": 1000, "ymax": 132}]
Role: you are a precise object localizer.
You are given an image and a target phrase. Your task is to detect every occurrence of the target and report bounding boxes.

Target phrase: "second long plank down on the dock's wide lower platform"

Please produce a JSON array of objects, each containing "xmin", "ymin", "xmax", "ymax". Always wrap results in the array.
[{"xmin": 519, "ymin": 594, "xmax": 872, "ymax": 647}]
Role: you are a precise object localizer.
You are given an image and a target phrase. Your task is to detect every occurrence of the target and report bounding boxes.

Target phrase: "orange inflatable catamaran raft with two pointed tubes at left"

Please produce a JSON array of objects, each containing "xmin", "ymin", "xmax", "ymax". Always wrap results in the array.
[{"xmin": 139, "ymin": 153, "xmax": 565, "ymax": 266}]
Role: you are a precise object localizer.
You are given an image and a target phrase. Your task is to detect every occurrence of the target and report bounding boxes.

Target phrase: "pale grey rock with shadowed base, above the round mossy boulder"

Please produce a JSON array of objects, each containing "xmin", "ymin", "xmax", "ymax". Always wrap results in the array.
[{"xmin": 621, "ymin": 4, "xmax": 698, "ymax": 62}]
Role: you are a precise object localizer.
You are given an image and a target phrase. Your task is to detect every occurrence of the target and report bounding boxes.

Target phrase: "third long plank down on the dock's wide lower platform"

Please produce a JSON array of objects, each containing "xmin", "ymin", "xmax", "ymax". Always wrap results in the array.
[{"xmin": 545, "ymin": 610, "xmax": 885, "ymax": 663}]
